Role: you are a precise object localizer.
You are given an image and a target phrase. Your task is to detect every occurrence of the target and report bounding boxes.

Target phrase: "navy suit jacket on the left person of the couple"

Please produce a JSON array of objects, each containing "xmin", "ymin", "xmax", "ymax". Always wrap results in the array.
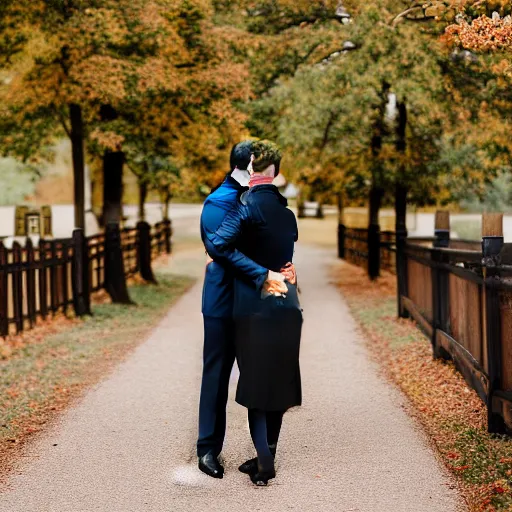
[{"xmin": 201, "ymin": 176, "xmax": 268, "ymax": 318}]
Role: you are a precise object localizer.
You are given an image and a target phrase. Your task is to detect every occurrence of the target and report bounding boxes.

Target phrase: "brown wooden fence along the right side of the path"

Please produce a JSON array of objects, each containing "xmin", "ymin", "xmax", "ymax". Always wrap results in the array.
[{"xmin": 339, "ymin": 214, "xmax": 512, "ymax": 434}]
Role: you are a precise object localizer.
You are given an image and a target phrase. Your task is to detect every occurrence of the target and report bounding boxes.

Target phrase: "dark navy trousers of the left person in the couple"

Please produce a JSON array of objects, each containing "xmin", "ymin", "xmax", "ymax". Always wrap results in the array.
[{"xmin": 197, "ymin": 316, "xmax": 235, "ymax": 457}]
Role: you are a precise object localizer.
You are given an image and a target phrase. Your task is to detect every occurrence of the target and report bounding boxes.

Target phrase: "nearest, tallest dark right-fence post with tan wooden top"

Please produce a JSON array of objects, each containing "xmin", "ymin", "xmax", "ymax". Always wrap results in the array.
[{"xmin": 482, "ymin": 213, "xmax": 506, "ymax": 434}]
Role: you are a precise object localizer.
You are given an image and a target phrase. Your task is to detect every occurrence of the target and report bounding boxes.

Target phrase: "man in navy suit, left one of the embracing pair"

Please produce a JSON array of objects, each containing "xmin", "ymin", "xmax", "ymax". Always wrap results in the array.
[{"xmin": 197, "ymin": 141, "xmax": 268, "ymax": 478}]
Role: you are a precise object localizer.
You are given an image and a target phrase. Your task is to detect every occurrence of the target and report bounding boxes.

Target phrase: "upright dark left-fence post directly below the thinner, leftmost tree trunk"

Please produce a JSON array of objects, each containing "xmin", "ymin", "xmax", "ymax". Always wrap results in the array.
[{"xmin": 71, "ymin": 229, "xmax": 91, "ymax": 316}]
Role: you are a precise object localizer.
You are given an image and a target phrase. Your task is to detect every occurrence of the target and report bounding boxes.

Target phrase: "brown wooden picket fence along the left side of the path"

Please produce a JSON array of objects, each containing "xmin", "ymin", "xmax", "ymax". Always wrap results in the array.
[{"xmin": 0, "ymin": 221, "xmax": 172, "ymax": 336}]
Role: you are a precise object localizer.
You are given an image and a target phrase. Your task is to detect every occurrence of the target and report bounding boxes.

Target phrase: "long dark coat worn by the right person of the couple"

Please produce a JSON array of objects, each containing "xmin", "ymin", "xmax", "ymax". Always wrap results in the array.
[{"xmin": 204, "ymin": 185, "xmax": 302, "ymax": 411}]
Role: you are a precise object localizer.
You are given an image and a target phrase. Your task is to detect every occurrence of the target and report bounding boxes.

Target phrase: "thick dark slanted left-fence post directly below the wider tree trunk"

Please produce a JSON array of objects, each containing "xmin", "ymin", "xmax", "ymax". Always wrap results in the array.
[{"xmin": 105, "ymin": 222, "xmax": 133, "ymax": 304}]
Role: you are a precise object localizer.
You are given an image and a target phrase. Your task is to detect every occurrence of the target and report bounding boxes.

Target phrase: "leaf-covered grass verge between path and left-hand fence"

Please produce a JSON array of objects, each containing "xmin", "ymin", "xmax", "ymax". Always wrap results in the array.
[{"xmin": 0, "ymin": 275, "xmax": 194, "ymax": 479}]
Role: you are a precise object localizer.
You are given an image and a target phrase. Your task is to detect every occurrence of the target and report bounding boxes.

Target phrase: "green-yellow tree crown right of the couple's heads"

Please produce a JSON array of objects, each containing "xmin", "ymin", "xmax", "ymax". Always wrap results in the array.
[{"xmin": 249, "ymin": 2, "xmax": 444, "ymax": 218}]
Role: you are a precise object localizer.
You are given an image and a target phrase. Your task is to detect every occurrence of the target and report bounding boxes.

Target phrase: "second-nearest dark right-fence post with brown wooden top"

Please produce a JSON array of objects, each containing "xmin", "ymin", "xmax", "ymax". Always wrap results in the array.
[{"xmin": 432, "ymin": 211, "xmax": 450, "ymax": 359}]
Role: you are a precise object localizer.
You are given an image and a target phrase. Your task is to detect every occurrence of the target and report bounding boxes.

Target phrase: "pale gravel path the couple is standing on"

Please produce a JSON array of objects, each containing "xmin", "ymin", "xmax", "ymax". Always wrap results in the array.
[{"xmin": 0, "ymin": 242, "xmax": 461, "ymax": 512}]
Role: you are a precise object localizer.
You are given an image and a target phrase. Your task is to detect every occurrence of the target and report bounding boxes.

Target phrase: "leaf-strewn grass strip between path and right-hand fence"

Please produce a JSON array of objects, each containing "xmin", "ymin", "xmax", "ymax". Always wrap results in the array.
[{"xmin": 333, "ymin": 262, "xmax": 512, "ymax": 512}]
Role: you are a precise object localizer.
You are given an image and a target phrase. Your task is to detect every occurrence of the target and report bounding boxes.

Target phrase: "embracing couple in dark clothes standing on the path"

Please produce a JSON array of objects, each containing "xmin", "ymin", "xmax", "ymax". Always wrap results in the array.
[{"xmin": 197, "ymin": 141, "xmax": 302, "ymax": 486}]
